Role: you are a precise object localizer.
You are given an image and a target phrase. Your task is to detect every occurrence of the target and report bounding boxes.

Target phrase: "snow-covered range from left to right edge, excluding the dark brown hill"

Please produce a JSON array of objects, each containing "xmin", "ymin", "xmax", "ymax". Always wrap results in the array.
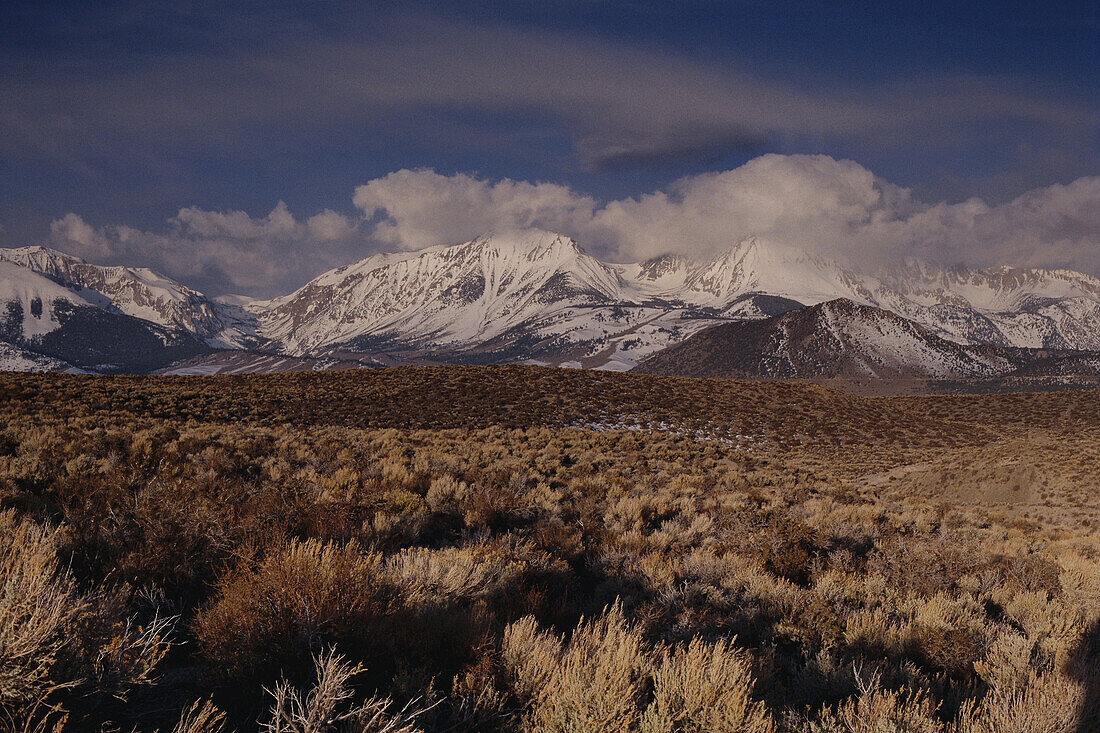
[{"xmin": 0, "ymin": 230, "xmax": 1100, "ymax": 369}]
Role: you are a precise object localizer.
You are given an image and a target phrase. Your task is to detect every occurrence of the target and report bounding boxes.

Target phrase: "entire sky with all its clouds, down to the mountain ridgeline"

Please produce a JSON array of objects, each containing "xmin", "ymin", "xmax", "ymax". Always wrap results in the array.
[{"xmin": 0, "ymin": 0, "xmax": 1100, "ymax": 296}]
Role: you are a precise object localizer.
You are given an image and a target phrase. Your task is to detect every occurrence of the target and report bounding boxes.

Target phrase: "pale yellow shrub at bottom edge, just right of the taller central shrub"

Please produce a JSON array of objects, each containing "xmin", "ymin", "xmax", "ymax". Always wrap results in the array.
[{"xmin": 641, "ymin": 639, "xmax": 776, "ymax": 733}]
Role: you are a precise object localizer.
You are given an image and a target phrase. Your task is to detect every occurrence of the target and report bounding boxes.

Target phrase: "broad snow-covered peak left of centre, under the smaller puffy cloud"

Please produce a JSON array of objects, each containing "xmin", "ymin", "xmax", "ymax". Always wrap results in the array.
[{"xmin": 256, "ymin": 230, "xmax": 622, "ymax": 353}]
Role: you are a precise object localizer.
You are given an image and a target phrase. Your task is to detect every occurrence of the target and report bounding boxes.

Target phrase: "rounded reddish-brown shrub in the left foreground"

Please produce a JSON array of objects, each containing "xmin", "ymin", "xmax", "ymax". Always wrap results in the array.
[{"xmin": 195, "ymin": 540, "xmax": 386, "ymax": 678}]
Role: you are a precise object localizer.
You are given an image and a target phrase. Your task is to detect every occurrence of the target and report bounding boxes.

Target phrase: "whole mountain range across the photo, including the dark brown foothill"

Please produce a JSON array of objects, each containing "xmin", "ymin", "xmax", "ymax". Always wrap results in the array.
[{"xmin": 0, "ymin": 230, "xmax": 1100, "ymax": 379}]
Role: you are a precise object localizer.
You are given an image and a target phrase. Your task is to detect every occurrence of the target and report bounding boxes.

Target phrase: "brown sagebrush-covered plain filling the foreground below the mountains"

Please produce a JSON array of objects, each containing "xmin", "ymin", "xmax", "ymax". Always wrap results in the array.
[{"xmin": 0, "ymin": 367, "xmax": 1100, "ymax": 733}]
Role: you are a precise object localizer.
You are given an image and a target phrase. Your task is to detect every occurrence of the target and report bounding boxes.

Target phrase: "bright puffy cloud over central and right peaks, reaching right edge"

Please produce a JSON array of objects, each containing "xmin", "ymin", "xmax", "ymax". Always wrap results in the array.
[{"xmin": 354, "ymin": 154, "xmax": 1100, "ymax": 274}]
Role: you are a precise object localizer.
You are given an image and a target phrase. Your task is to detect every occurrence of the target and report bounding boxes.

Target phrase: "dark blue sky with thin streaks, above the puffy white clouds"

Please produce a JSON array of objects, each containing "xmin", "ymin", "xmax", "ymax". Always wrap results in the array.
[{"xmin": 0, "ymin": 0, "xmax": 1100, "ymax": 256}]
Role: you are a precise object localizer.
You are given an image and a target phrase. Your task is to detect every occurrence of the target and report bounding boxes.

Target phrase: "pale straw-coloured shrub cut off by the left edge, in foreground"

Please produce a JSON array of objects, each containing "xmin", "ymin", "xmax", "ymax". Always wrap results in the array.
[{"xmin": 0, "ymin": 512, "xmax": 83, "ymax": 713}]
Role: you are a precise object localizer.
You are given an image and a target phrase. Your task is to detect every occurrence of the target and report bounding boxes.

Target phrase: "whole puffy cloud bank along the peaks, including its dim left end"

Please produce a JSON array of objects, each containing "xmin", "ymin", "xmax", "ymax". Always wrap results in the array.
[{"xmin": 51, "ymin": 155, "xmax": 1100, "ymax": 295}]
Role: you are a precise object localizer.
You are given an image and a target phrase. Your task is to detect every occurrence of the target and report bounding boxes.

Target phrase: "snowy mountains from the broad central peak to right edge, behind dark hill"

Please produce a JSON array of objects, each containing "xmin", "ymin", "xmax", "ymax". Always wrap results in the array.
[{"xmin": 250, "ymin": 230, "xmax": 1100, "ymax": 369}]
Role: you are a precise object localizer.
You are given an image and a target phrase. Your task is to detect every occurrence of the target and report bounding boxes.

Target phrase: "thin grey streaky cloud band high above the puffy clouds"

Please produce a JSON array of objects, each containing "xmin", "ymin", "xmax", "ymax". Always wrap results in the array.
[{"xmin": 0, "ymin": 12, "xmax": 1100, "ymax": 177}]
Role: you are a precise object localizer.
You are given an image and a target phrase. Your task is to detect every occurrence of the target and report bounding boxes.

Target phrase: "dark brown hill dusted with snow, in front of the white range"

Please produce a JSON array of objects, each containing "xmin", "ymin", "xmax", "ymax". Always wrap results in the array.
[{"xmin": 636, "ymin": 299, "xmax": 1012, "ymax": 379}]
